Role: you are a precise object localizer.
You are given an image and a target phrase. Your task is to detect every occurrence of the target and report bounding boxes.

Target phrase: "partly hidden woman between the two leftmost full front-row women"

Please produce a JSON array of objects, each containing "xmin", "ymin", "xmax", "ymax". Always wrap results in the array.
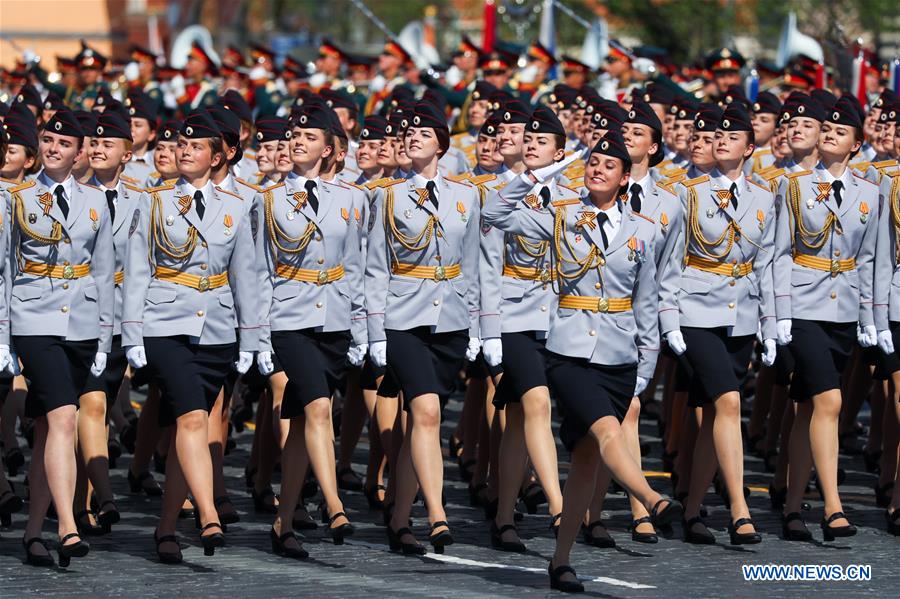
[{"xmin": 75, "ymin": 111, "xmax": 143, "ymax": 534}]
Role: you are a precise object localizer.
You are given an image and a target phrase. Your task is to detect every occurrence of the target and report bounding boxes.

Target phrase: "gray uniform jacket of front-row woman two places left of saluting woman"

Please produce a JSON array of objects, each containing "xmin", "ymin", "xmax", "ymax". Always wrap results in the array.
[{"xmin": 365, "ymin": 171, "xmax": 481, "ymax": 343}]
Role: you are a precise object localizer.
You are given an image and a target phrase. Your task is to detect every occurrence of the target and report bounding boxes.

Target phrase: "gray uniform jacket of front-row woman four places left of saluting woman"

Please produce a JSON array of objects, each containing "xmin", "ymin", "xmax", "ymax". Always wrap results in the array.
[{"xmin": 122, "ymin": 179, "xmax": 259, "ymax": 351}]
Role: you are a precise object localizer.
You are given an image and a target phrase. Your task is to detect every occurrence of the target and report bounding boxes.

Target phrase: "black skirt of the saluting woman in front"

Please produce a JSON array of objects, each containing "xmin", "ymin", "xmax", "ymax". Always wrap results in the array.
[{"xmin": 547, "ymin": 352, "xmax": 637, "ymax": 451}]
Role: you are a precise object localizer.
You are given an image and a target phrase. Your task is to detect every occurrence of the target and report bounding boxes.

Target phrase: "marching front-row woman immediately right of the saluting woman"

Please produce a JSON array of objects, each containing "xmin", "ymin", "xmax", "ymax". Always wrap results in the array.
[{"xmin": 660, "ymin": 103, "xmax": 776, "ymax": 545}]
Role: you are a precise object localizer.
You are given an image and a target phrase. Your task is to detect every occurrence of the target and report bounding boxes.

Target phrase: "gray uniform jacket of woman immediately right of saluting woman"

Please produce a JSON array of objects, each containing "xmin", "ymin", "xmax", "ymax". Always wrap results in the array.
[{"xmin": 659, "ymin": 169, "xmax": 775, "ymax": 339}]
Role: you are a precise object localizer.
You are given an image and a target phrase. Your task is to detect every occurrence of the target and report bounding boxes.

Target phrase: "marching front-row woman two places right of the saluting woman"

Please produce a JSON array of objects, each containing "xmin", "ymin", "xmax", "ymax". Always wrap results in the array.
[{"xmin": 775, "ymin": 98, "xmax": 887, "ymax": 541}]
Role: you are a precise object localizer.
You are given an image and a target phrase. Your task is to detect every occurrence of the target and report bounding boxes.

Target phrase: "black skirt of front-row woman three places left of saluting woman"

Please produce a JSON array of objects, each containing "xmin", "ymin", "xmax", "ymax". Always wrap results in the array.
[{"xmin": 272, "ymin": 329, "xmax": 350, "ymax": 418}]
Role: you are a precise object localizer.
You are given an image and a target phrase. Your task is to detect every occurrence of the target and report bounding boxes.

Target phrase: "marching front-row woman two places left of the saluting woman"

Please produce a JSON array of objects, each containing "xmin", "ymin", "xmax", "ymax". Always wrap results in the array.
[{"xmin": 365, "ymin": 102, "xmax": 480, "ymax": 553}]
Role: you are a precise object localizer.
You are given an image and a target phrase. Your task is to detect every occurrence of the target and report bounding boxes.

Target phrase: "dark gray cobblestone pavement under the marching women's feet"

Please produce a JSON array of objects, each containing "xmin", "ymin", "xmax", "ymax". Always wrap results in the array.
[{"xmin": 0, "ymin": 386, "xmax": 900, "ymax": 599}]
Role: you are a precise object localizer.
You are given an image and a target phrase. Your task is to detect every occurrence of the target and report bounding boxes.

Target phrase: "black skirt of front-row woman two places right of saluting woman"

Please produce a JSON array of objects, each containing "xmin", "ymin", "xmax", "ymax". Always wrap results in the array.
[{"xmin": 790, "ymin": 320, "xmax": 856, "ymax": 402}]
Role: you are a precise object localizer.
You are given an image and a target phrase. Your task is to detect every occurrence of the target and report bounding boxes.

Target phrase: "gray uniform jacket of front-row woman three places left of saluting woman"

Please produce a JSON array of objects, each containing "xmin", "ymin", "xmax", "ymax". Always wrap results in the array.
[{"xmin": 256, "ymin": 175, "xmax": 366, "ymax": 351}]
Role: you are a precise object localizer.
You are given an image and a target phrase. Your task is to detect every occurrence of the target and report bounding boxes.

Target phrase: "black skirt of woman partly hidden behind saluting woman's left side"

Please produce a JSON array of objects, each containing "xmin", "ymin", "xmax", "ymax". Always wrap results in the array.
[{"xmin": 485, "ymin": 331, "xmax": 548, "ymax": 409}]
